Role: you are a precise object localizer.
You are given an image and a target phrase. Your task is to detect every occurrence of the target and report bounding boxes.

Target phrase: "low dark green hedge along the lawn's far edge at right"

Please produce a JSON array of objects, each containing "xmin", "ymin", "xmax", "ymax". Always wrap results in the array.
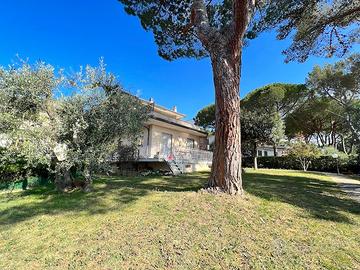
[{"xmin": 243, "ymin": 156, "xmax": 360, "ymax": 174}]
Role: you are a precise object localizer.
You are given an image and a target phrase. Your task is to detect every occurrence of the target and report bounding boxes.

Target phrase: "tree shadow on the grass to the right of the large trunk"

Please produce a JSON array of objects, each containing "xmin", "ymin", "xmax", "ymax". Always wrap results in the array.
[{"xmin": 244, "ymin": 172, "xmax": 360, "ymax": 223}]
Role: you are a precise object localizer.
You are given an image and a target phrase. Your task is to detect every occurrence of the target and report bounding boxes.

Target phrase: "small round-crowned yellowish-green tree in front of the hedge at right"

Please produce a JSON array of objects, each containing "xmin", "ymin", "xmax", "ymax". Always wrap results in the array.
[{"xmin": 289, "ymin": 142, "xmax": 321, "ymax": 172}]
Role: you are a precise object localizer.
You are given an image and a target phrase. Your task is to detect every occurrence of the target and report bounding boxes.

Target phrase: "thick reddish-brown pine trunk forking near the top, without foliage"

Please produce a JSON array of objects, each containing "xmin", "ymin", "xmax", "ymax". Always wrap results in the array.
[{"xmin": 191, "ymin": 0, "xmax": 255, "ymax": 194}]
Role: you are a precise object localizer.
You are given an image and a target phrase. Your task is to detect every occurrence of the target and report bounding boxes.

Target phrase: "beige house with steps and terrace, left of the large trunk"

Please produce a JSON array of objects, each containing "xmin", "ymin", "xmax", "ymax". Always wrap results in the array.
[{"xmin": 114, "ymin": 99, "xmax": 212, "ymax": 174}]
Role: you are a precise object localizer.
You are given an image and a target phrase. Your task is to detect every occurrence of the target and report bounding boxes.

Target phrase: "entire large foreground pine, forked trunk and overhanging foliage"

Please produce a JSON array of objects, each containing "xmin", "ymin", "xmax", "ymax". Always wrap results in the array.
[{"xmin": 120, "ymin": 0, "xmax": 360, "ymax": 194}]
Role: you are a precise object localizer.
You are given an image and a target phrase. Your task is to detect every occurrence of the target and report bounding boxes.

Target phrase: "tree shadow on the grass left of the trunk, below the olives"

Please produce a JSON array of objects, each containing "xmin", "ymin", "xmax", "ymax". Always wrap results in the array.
[{"xmin": 0, "ymin": 173, "xmax": 208, "ymax": 225}]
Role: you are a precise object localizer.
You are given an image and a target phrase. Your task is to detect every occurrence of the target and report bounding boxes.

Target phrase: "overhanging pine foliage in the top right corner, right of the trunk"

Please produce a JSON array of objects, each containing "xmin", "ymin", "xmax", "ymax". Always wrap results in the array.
[{"xmin": 251, "ymin": 0, "xmax": 360, "ymax": 62}]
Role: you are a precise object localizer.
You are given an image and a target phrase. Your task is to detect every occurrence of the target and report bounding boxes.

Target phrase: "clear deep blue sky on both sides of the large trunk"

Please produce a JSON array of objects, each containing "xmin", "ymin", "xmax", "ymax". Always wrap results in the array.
[{"xmin": 0, "ymin": 0, "xmax": 348, "ymax": 119}]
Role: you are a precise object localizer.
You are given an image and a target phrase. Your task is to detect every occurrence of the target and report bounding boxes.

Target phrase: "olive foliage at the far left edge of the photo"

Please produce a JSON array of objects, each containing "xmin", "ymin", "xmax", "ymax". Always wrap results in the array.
[{"xmin": 0, "ymin": 60, "xmax": 63, "ymax": 186}]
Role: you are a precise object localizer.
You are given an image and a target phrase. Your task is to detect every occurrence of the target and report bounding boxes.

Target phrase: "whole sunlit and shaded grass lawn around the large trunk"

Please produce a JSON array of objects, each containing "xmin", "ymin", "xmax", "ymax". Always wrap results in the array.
[{"xmin": 0, "ymin": 170, "xmax": 360, "ymax": 270}]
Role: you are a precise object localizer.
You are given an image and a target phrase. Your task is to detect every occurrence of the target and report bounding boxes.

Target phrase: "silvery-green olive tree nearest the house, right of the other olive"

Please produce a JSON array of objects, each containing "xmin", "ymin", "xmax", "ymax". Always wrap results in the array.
[{"xmin": 56, "ymin": 62, "xmax": 148, "ymax": 191}]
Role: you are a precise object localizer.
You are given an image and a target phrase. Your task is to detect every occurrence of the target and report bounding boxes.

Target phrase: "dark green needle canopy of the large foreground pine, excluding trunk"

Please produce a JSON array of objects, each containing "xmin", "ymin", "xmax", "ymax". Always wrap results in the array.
[{"xmin": 120, "ymin": 0, "xmax": 359, "ymax": 61}]
